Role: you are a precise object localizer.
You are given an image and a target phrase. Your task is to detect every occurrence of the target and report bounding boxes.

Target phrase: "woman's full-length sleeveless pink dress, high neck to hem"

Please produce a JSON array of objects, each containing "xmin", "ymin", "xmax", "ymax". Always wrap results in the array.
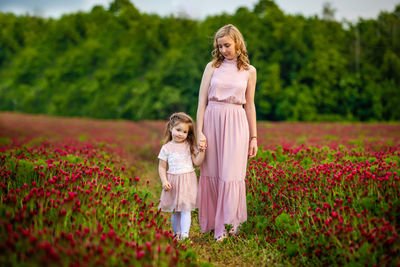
[{"xmin": 198, "ymin": 59, "xmax": 249, "ymax": 238}]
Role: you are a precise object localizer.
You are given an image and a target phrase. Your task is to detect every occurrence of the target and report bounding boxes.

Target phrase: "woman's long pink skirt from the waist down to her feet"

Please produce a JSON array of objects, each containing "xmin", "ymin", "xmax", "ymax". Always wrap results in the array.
[{"xmin": 198, "ymin": 102, "xmax": 249, "ymax": 238}]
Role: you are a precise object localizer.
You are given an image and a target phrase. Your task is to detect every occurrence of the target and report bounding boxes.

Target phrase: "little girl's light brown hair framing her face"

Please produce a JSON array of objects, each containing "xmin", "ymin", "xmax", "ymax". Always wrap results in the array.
[{"xmin": 164, "ymin": 112, "xmax": 196, "ymax": 154}]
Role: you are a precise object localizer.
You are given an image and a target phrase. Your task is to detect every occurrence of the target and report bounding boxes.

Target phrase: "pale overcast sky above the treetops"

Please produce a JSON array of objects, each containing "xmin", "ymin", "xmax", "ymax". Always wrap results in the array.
[{"xmin": 0, "ymin": 0, "xmax": 400, "ymax": 22}]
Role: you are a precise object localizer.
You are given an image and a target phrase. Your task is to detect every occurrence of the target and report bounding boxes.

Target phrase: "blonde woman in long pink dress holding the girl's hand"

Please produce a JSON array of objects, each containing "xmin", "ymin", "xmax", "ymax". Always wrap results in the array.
[{"xmin": 197, "ymin": 24, "xmax": 257, "ymax": 242}]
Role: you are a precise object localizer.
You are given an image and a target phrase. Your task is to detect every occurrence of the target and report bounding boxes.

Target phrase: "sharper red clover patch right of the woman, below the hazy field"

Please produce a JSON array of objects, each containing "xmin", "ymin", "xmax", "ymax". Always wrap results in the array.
[{"xmin": 243, "ymin": 147, "xmax": 400, "ymax": 266}]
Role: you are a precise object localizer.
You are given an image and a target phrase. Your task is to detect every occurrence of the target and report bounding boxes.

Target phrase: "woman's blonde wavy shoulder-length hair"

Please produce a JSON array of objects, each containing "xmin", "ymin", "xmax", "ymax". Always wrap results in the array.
[{"xmin": 211, "ymin": 24, "xmax": 250, "ymax": 70}]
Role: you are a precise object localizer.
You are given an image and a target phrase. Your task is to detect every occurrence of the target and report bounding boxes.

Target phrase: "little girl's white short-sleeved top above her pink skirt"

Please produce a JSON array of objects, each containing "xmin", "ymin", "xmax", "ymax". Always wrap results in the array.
[{"xmin": 158, "ymin": 142, "xmax": 194, "ymax": 174}]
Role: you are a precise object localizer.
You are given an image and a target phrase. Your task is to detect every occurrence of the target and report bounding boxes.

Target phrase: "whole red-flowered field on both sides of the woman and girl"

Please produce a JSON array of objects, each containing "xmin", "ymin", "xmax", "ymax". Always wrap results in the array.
[{"xmin": 0, "ymin": 113, "xmax": 400, "ymax": 266}]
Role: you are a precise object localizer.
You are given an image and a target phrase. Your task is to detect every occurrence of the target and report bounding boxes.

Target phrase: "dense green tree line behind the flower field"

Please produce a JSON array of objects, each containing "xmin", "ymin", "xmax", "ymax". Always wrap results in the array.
[{"xmin": 0, "ymin": 0, "xmax": 400, "ymax": 121}]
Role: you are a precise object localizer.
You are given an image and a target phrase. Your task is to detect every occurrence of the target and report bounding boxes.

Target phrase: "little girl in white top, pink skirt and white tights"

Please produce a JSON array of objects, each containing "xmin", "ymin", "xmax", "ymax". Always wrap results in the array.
[{"xmin": 158, "ymin": 112, "xmax": 205, "ymax": 239}]
